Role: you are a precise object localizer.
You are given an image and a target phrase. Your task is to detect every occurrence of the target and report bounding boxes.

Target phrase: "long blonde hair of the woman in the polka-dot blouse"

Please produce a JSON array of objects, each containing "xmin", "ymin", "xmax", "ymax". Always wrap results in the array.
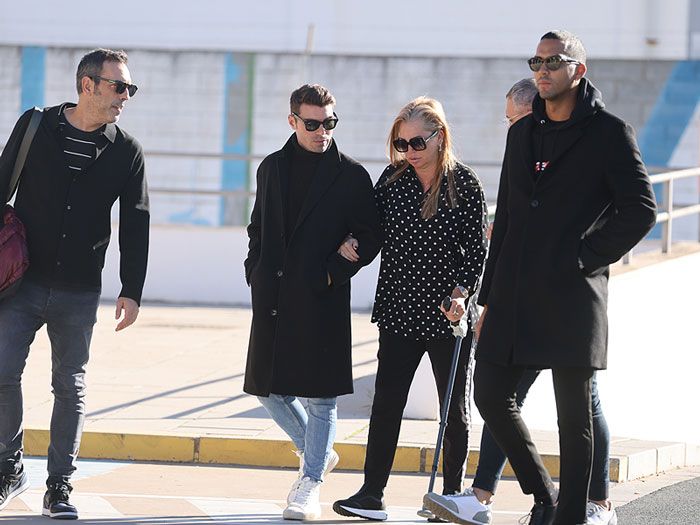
[{"xmin": 386, "ymin": 97, "xmax": 457, "ymax": 219}]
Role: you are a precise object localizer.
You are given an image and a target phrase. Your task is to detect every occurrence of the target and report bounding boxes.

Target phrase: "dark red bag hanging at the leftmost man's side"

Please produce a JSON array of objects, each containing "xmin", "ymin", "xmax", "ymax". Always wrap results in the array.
[{"xmin": 0, "ymin": 204, "xmax": 29, "ymax": 299}]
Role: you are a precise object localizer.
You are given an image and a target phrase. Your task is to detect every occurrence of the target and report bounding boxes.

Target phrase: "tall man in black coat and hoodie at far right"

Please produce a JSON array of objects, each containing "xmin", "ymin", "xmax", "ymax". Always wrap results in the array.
[{"xmin": 426, "ymin": 31, "xmax": 656, "ymax": 525}]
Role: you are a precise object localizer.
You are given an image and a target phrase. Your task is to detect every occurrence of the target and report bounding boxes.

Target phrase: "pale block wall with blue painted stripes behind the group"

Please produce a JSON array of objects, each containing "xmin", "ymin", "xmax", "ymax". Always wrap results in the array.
[{"xmin": 0, "ymin": 45, "xmax": 700, "ymax": 308}]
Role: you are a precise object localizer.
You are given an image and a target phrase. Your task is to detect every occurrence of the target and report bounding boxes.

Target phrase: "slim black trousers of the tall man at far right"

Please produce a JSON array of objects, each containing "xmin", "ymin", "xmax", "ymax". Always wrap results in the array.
[{"xmin": 474, "ymin": 359, "xmax": 593, "ymax": 525}]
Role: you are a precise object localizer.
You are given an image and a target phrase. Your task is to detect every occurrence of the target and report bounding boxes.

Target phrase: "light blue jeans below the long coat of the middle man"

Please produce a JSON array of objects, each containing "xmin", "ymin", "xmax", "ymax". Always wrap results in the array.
[{"xmin": 258, "ymin": 394, "xmax": 338, "ymax": 481}]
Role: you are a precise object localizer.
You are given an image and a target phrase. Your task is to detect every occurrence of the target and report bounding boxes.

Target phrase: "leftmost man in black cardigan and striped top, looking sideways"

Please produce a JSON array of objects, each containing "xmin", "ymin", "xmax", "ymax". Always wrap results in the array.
[{"xmin": 0, "ymin": 49, "xmax": 149, "ymax": 519}]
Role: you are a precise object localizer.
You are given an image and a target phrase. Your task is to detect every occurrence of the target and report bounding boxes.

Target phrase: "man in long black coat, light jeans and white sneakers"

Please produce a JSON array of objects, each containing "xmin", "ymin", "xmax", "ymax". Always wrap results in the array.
[{"xmin": 243, "ymin": 84, "xmax": 381, "ymax": 520}]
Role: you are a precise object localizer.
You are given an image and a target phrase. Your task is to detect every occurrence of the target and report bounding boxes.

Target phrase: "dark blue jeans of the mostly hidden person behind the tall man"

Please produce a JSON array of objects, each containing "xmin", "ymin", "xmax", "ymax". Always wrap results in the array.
[{"xmin": 472, "ymin": 370, "xmax": 610, "ymax": 501}]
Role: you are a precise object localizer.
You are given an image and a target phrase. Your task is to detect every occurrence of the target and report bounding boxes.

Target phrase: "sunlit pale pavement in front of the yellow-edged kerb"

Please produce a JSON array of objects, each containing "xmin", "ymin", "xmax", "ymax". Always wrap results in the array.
[{"xmin": 5, "ymin": 458, "xmax": 700, "ymax": 525}]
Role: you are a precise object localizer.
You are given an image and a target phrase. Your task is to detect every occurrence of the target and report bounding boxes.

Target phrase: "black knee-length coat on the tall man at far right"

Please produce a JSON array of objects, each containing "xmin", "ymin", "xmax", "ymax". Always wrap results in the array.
[{"xmin": 477, "ymin": 79, "xmax": 656, "ymax": 369}]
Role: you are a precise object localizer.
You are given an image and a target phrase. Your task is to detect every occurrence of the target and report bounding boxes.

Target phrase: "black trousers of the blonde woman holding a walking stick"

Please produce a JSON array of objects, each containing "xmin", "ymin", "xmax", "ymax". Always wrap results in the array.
[{"xmin": 364, "ymin": 330, "xmax": 471, "ymax": 494}]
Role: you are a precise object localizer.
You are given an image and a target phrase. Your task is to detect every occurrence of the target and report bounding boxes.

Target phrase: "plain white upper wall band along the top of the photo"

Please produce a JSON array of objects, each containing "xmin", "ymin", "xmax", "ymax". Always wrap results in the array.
[{"xmin": 0, "ymin": 0, "xmax": 690, "ymax": 59}]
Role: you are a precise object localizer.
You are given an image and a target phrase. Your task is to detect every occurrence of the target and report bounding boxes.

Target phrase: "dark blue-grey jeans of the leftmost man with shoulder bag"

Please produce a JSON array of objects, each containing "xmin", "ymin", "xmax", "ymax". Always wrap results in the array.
[{"xmin": 0, "ymin": 281, "xmax": 100, "ymax": 482}]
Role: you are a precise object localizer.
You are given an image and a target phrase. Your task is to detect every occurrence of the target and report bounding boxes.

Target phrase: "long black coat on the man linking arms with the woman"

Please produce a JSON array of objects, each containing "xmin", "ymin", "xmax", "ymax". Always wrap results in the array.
[{"xmin": 243, "ymin": 135, "xmax": 381, "ymax": 397}]
